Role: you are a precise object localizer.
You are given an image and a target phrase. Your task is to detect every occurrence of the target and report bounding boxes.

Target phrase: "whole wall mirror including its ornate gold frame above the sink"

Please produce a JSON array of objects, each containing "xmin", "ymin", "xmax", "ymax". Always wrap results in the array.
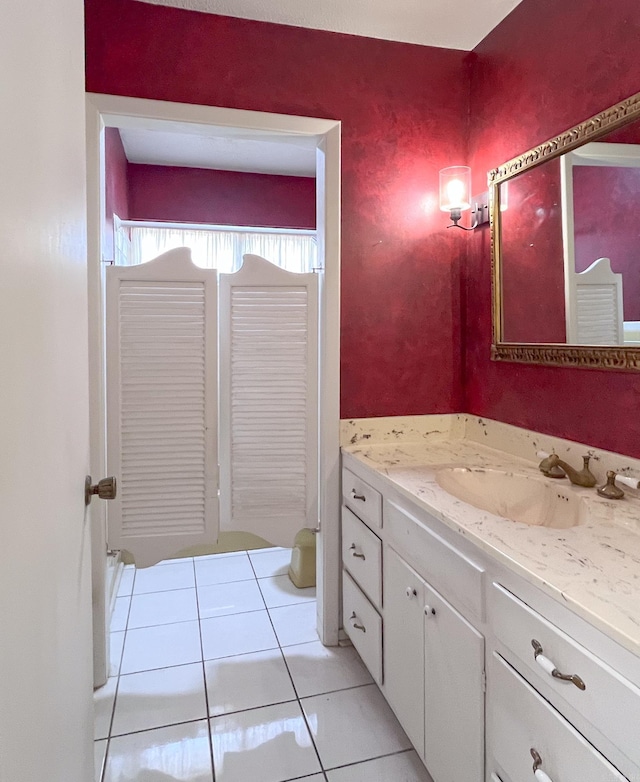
[{"xmin": 488, "ymin": 93, "xmax": 640, "ymax": 370}]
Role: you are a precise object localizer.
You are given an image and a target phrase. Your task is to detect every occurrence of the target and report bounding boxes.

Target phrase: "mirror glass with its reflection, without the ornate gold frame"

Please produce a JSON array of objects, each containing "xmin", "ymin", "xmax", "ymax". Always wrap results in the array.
[{"xmin": 497, "ymin": 121, "xmax": 640, "ymax": 348}]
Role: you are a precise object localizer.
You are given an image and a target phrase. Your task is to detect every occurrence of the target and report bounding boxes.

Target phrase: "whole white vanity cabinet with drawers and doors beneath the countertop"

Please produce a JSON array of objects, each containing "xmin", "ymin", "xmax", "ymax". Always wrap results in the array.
[{"xmin": 342, "ymin": 459, "xmax": 640, "ymax": 782}]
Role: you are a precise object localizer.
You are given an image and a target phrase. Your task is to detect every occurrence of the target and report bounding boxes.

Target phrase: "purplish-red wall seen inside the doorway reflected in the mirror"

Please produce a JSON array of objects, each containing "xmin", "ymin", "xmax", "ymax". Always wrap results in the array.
[{"xmin": 573, "ymin": 166, "xmax": 640, "ymax": 320}]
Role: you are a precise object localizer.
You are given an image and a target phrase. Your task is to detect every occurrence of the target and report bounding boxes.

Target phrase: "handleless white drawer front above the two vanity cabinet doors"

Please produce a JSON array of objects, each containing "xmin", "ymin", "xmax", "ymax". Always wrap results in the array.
[{"xmin": 384, "ymin": 500, "xmax": 484, "ymax": 620}]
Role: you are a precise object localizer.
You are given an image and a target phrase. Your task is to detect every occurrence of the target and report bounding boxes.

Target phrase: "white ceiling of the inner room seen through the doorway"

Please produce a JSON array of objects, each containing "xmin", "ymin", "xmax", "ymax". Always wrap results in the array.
[{"xmin": 120, "ymin": 128, "xmax": 316, "ymax": 176}]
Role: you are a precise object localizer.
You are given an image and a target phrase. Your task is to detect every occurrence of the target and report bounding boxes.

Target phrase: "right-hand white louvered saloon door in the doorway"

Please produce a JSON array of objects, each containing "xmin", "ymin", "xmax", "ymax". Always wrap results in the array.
[{"xmin": 220, "ymin": 255, "xmax": 318, "ymax": 546}]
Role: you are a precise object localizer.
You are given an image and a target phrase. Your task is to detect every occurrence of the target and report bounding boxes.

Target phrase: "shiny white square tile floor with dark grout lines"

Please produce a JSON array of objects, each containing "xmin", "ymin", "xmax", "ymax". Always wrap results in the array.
[{"xmin": 94, "ymin": 549, "xmax": 429, "ymax": 782}]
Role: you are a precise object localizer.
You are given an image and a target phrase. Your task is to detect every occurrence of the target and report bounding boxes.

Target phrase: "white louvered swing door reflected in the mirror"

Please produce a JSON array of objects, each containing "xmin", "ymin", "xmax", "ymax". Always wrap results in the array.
[{"xmin": 574, "ymin": 258, "xmax": 624, "ymax": 345}]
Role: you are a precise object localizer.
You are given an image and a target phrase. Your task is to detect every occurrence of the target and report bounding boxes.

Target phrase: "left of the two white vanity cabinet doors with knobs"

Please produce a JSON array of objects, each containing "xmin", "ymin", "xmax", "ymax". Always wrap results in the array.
[{"xmin": 384, "ymin": 548, "xmax": 425, "ymax": 755}]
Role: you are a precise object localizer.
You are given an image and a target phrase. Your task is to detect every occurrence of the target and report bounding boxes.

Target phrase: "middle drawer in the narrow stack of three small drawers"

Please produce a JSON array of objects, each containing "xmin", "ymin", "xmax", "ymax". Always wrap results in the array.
[{"xmin": 342, "ymin": 507, "xmax": 382, "ymax": 607}]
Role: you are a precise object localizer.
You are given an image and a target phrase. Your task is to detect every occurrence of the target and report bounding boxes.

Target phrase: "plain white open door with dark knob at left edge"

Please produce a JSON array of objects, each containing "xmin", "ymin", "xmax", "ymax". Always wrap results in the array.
[{"xmin": 0, "ymin": 0, "xmax": 92, "ymax": 782}]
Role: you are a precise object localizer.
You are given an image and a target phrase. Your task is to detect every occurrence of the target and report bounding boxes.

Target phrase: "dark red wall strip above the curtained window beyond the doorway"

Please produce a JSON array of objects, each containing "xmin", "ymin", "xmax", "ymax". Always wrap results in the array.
[{"xmin": 128, "ymin": 163, "xmax": 316, "ymax": 228}]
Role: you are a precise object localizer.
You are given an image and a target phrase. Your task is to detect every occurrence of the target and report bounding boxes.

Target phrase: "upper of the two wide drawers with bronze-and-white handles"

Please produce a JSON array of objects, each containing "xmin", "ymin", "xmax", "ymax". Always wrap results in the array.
[{"xmin": 489, "ymin": 584, "xmax": 640, "ymax": 768}]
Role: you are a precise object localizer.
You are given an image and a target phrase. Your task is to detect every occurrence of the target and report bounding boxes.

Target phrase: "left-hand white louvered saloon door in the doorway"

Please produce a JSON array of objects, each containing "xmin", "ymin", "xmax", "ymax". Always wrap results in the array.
[{"xmin": 106, "ymin": 248, "xmax": 218, "ymax": 567}]
